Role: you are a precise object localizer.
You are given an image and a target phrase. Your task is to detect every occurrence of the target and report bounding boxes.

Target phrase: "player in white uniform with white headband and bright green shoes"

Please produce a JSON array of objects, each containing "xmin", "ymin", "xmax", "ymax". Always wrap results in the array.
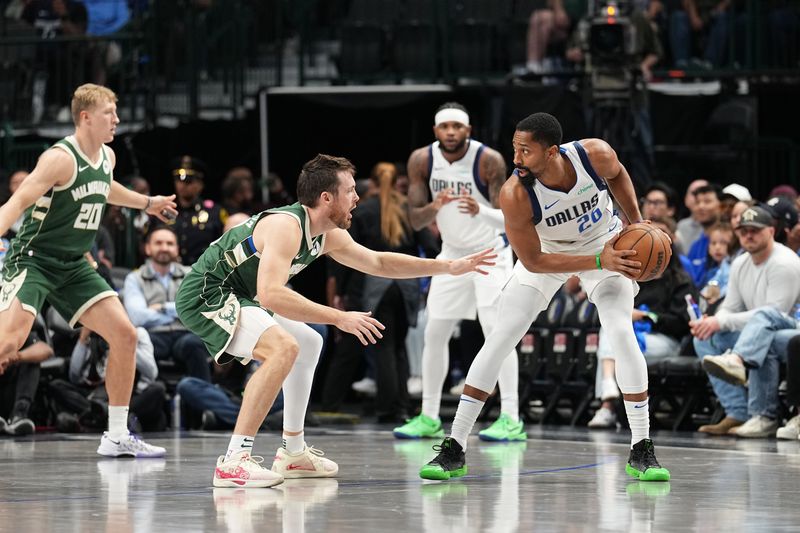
[{"xmin": 394, "ymin": 102, "xmax": 527, "ymax": 441}]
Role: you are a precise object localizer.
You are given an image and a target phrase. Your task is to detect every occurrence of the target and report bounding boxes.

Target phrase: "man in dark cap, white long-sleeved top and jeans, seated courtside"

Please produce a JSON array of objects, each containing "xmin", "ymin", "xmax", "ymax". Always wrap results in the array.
[{"xmin": 689, "ymin": 206, "xmax": 800, "ymax": 435}]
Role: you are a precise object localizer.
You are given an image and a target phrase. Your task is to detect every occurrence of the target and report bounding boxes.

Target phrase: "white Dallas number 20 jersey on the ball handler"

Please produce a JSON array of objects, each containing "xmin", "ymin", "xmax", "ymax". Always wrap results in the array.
[{"xmin": 515, "ymin": 141, "xmax": 622, "ymax": 252}]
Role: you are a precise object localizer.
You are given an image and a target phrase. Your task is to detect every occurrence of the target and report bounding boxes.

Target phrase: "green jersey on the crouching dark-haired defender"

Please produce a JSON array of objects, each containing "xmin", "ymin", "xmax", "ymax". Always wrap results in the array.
[{"xmin": 192, "ymin": 203, "xmax": 325, "ymax": 307}]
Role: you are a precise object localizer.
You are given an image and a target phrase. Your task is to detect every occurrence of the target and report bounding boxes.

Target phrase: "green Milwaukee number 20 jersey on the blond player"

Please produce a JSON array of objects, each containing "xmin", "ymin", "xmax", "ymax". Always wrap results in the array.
[{"xmin": 9, "ymin": 135, "xmax": 113, "ymax": 258}]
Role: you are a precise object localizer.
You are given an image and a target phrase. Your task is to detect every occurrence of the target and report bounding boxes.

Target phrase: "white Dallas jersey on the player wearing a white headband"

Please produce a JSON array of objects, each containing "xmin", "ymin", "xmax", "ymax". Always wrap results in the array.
[{"xmin": 428, "ymin": 139, "xmax": 498, "ymax": 250}]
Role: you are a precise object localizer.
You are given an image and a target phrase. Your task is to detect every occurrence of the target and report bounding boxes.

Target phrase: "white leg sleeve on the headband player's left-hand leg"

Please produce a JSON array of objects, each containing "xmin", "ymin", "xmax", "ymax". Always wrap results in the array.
[{"xmin": 422, "ymin": 316, "xmax": 458, "ymax": 420}]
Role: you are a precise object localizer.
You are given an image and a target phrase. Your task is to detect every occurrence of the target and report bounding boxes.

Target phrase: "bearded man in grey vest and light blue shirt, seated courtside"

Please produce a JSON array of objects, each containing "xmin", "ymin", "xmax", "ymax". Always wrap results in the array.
[{"xmin": 124, "ymin": 226, "xmax": 211, "ymax": 382}]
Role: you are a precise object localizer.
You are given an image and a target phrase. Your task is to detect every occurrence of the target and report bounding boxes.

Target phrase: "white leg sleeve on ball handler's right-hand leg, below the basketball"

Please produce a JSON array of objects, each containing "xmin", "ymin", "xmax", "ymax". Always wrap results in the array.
[{"xmin": 592, "ymin": 276, "xmax": 647, "ymax": 394}]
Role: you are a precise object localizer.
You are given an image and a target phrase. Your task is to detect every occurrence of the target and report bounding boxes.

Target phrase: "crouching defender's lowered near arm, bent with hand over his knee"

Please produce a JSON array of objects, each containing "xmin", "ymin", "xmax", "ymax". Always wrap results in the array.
[{"xmin": 253, "ymin": 214, "xmax": 384, "ymax": 345}]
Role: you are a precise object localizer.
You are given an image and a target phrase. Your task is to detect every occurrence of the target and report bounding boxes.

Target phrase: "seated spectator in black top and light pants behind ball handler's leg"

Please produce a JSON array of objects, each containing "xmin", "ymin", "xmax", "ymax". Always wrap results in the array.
[{"xmin": 589, "ymin": 214, "xmax": 697, "ymax": 428}]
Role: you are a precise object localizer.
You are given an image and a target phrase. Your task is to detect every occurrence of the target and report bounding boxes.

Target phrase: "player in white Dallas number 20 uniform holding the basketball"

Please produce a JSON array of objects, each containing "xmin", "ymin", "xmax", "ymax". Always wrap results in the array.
[{"xmin": 420, "ymin": 113, "xmax": 669, "ymax": 481}]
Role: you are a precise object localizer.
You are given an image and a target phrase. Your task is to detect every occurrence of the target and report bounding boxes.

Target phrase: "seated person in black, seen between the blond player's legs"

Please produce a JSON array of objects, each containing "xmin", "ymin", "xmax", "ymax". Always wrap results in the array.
[{"xmin": 0, "ymin": 327, "xmax": 53, "ymax": 435}]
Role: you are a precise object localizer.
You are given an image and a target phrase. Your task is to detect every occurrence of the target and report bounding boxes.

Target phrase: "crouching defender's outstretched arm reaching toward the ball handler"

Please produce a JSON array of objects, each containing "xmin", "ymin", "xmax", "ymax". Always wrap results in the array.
[{"xmin": 325, "ymin": 225, "xmax": 497, "ymax": 279}]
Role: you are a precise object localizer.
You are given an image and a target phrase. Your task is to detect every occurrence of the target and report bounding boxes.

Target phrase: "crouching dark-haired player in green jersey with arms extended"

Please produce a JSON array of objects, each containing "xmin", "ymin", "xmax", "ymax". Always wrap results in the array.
[{"xmin": 175, "ymin": 155, "xmax": 496, "ymax": 487}]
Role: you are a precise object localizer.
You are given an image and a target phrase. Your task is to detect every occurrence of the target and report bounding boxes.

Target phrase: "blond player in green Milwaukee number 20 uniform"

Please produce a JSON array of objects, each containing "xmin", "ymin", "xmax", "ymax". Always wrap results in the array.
[{"xmin": 0, "ymin": 84, "xmax": 177, "ymax": 457}]
